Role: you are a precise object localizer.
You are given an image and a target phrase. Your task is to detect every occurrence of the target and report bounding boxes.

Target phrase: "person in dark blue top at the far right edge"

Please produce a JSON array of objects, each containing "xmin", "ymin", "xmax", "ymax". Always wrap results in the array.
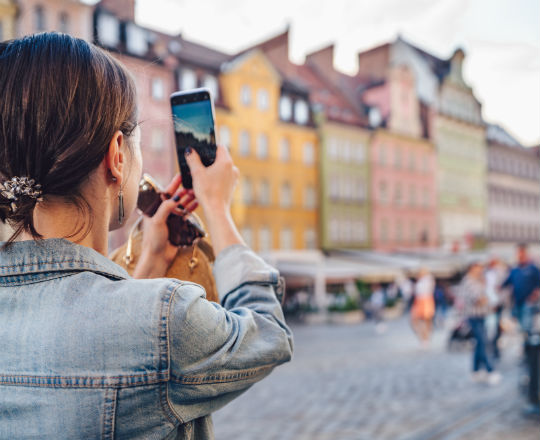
[{"xmin": 501, "ymin": 243, "xmax": 540, "ymax": 333}]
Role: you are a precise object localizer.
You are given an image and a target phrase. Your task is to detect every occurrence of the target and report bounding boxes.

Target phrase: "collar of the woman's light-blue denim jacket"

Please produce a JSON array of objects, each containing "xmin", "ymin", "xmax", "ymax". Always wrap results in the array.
[{"xmin": 0, "ymin": 238, "xmax": 131, "ymax": 279}]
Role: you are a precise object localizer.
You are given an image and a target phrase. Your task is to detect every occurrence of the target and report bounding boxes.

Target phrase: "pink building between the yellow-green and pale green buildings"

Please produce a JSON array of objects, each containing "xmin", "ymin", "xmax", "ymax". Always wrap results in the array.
[{"xmin": 362, "ymin": 66, "xmax": 439, "ymax": 251}]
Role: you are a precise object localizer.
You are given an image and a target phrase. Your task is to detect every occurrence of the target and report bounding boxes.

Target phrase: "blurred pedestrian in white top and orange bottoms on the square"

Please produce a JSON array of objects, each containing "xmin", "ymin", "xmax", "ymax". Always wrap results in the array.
[{"xmin": 411, "ymin": 268, "xmax": 435, "ymax": 348}]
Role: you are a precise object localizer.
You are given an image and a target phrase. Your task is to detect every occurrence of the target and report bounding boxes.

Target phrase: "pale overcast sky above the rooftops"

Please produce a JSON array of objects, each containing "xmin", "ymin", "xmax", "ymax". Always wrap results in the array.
[{"xmin": 127, "ymin": 0, "xmax": 540, "ymax": 145}]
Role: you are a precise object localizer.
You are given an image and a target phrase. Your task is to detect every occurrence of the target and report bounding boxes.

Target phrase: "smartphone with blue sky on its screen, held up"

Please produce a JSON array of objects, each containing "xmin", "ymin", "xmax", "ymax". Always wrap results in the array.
[{"xmin": 171, "ymin": 87, "xmax": 217, "ymax": 189}]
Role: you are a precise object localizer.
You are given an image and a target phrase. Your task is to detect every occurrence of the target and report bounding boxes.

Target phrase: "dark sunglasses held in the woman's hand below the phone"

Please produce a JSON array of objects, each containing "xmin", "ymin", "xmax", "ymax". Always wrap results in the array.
[{"xmin": 137, "ymin": 174, "xmax": 206, "ymax": 246}]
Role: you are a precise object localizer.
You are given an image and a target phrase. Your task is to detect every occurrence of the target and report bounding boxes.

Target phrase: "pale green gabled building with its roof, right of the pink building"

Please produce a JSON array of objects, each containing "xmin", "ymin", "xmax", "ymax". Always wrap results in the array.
[{"xmin": 358, "ymin": 38, "xmax": 487, "ymax": 250}]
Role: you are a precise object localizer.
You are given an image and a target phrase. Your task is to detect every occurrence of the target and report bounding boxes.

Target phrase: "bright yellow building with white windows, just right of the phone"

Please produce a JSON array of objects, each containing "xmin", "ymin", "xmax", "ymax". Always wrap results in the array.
[{"xmin": 216, "ymin": 49, "xmax": 319, "ymax": 252}]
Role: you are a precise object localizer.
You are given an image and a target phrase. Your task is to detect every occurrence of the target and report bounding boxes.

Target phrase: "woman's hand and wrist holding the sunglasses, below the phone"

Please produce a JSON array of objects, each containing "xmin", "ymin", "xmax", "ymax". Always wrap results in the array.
[{"xmin": 133, "ymin": 174, "xmax": 198, "ymax": 278}]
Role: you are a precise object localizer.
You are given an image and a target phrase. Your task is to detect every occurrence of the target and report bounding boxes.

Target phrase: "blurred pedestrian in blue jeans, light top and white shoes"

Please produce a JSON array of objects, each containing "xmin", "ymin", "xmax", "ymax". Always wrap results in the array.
[{"xmin": 459, "ymin": 263, "xmax": 501, "ymax": 385}]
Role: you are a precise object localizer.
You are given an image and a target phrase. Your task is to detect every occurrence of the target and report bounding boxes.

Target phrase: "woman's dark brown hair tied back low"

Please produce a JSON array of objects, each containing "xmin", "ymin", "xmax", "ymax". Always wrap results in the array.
[{"xmin": 0, "ymin": 32, "xmax": 137, "ymax": 246}]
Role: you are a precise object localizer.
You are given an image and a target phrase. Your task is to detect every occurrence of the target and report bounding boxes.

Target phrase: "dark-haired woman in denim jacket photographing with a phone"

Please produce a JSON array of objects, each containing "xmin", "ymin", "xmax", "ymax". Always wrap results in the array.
[{"xmin": 0, "ymin": 33, "xmax": 292, "ymax": 439}]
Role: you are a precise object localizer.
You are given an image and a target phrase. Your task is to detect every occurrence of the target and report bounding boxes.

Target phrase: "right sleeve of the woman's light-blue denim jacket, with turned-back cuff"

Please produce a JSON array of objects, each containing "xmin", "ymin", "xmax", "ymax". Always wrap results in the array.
[{"xmin": 167, "ymin": 245, "xmax": 292, "ymax": 423}]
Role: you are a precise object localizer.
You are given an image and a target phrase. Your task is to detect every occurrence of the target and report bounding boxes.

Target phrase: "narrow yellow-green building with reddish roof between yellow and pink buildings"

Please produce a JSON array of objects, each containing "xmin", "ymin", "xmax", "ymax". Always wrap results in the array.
[{"xmin": 250, "ymin": 29, "xmax": 370, "ymax": 250}]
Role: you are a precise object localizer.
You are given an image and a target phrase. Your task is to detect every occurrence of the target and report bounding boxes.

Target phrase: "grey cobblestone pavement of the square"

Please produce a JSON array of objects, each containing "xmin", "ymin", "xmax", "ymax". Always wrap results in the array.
[{"xmin": 214, "ymin": 319, "xmax": 540, "ymax": 440}]
